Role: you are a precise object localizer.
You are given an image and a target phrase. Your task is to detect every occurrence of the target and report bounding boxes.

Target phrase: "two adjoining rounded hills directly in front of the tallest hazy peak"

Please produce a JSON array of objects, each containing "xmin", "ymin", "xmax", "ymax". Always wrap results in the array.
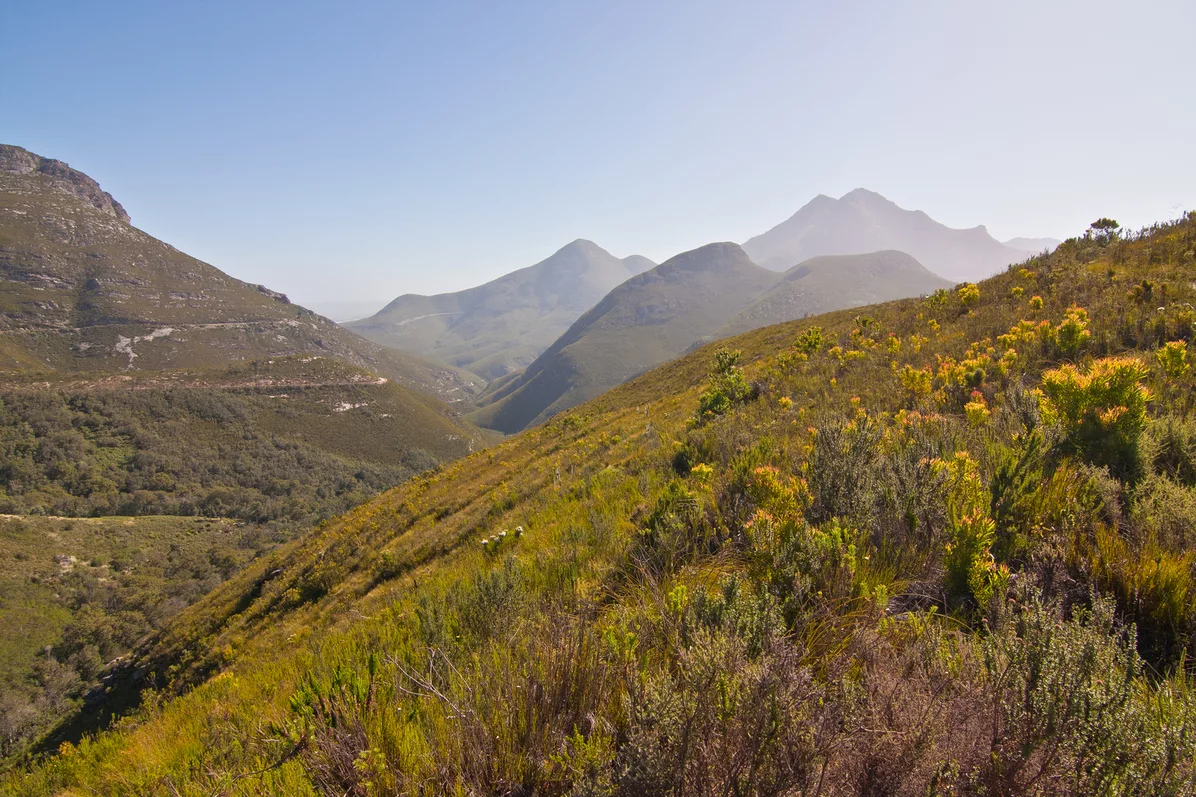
[{"xmin": 470, "ymin": 243, "xmax": 951, "ymax": 433}]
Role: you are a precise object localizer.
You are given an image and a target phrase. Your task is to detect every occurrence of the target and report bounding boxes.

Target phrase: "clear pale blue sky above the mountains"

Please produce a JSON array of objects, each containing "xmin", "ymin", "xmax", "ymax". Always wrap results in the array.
[{"xmin": 0, "ymin": 0, "xmax": 1196, "ymax": 304}]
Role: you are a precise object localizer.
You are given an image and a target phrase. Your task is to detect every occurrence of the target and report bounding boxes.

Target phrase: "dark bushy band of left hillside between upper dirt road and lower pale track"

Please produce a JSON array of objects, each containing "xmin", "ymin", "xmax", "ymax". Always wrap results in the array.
[{"xmin": 0, "ymin": 358, "xmax": 493, "ymax": 523}]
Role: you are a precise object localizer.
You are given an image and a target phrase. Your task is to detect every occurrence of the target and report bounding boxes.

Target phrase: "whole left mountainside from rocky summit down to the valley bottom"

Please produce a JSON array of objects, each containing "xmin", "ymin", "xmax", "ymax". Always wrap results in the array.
[{"xmin": 0, "ymin": 147, "xmax": 498, "ymax": 756}]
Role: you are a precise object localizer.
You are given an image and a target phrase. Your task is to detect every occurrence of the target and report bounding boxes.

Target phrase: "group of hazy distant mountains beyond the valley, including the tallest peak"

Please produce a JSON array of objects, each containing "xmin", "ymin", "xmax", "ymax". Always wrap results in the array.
[{"xmin": 332, "ymin": 189, "xmax": 1057, "ymax": 433}]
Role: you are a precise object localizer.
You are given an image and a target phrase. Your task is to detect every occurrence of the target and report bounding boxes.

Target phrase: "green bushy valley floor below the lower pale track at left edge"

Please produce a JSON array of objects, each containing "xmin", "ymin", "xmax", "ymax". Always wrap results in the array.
[{"xmin": 0, "ymin": 516, "xmax": 278, "ymax": 758}]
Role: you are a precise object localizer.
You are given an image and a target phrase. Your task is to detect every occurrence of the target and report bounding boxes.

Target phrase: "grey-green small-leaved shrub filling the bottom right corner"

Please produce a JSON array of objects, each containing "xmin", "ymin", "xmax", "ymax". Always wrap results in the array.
[{"xmin": 978, "ymin": 597, "xmax": 1196, "ymax": 796}]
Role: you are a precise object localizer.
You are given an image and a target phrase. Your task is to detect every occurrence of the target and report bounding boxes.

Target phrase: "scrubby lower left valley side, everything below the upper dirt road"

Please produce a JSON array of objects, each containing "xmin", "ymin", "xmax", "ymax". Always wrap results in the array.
[{"xmin": 0, "ymin": 358, "xmax": 494, "ymax": 755}]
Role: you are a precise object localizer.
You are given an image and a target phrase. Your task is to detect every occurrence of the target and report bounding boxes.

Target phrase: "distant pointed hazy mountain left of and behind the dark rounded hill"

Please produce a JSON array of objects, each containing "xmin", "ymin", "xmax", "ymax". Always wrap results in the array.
[{"xmin": 346, "ymin": 239, "xmax": 655, "ymax": 379}]
